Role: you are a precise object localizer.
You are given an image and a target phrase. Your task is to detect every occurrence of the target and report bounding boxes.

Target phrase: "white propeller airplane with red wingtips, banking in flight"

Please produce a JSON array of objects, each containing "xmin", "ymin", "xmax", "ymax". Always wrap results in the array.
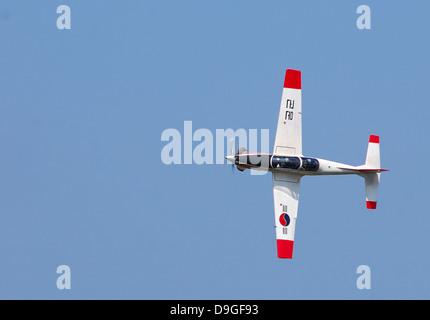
[{"xmin": 226, "ymin": 69, "xmax": 388, "ymax": 259}]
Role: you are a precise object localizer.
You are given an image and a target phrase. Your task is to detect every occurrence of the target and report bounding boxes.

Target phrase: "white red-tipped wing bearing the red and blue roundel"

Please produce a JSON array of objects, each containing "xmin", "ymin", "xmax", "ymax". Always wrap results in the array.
[{"xmin": 273, "ymin": 172, "xmax": 301, "ymax": 259}]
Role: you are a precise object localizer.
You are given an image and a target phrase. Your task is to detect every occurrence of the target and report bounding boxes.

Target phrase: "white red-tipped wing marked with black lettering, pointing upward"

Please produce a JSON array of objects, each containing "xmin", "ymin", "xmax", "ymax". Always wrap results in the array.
[{"xmin": 273, "ymin": 69, "xmax": 302, "ymax": 156}]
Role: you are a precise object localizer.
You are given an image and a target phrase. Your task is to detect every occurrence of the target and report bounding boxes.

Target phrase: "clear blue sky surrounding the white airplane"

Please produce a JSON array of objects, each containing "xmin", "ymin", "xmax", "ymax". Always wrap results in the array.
[{"xmin": 0, "ymin": 0, "xmax": 430, "ymax": 299}]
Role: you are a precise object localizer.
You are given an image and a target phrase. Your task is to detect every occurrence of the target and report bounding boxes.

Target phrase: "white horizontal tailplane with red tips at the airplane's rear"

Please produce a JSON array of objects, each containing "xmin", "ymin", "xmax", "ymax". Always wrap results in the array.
[{"xmin": 362, "ymin": 135, "xmax": 381, "ymax": 209}]
